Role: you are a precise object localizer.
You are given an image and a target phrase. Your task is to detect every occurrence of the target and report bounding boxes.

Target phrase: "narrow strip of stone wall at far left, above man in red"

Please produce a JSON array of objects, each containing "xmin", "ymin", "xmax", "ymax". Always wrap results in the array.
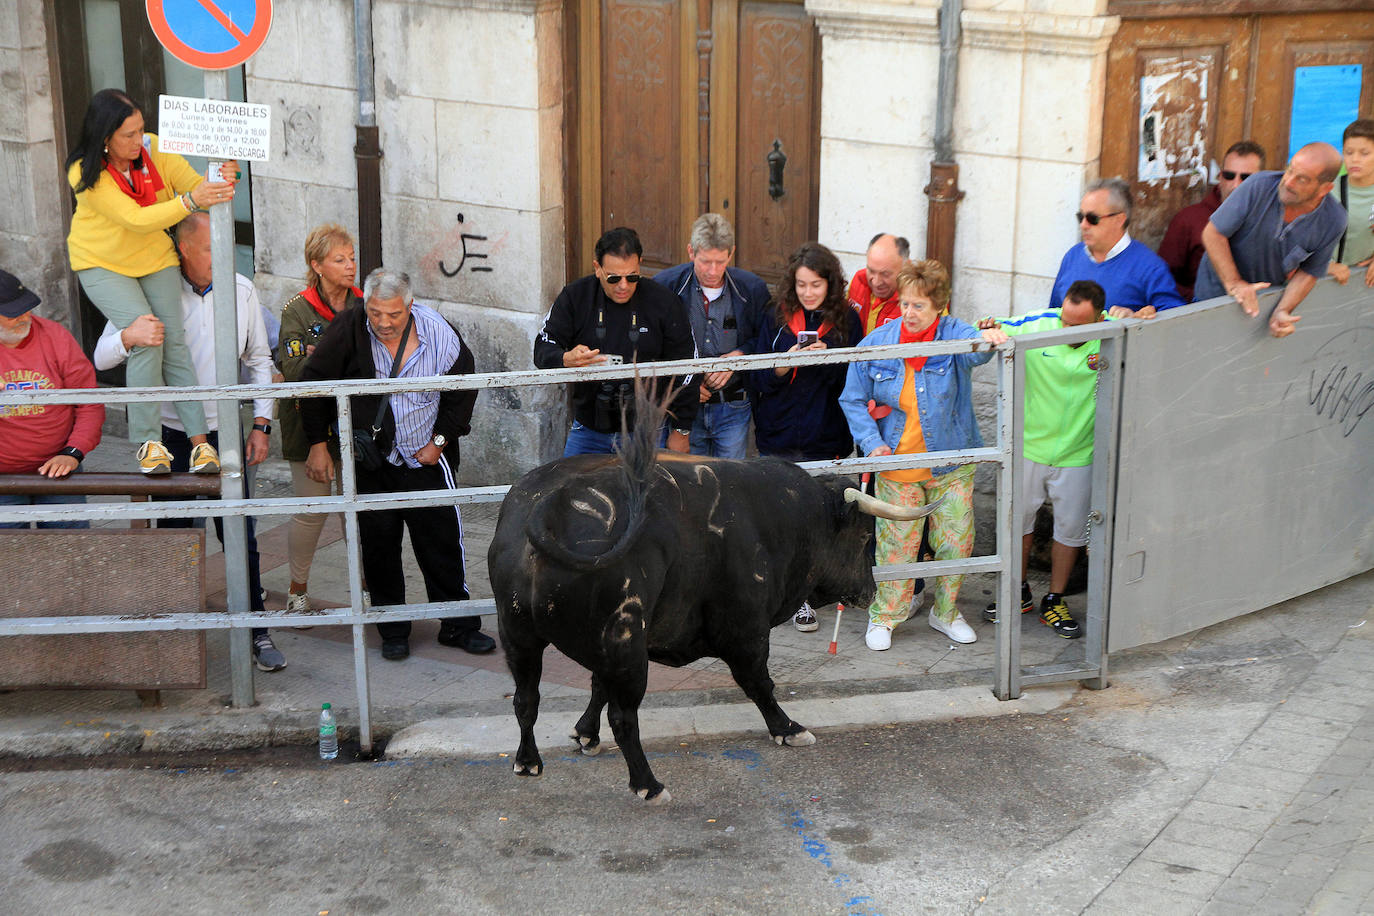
[{"xmin": 0, "ymin": 0, "xmax": 76, "ymax": 325}]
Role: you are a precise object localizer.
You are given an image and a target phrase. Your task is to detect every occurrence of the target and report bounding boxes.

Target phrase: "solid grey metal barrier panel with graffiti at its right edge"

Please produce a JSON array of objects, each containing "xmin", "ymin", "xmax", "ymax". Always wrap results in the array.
[{"xmin": 1109, "ymin": 272, "xmax": 1374, "ymax": 651}]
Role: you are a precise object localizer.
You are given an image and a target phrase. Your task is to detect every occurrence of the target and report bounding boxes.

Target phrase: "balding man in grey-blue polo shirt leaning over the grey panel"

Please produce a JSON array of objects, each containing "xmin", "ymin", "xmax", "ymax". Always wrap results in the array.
[{"xmin": 1194, "ymin": 143, "xmax": 1345, "ymax": 336}]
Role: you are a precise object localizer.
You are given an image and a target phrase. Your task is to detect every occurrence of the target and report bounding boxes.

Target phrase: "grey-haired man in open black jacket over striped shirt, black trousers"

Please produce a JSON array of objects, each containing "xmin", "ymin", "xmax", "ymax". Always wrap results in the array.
[{"xmin": 301, "ymin": 268, "xmax": 496, "ymax": 661}]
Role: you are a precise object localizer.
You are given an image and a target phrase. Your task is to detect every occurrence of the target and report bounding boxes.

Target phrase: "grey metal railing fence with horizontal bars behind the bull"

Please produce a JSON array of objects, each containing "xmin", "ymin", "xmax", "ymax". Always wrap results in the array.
[{"xmin": 0, "ymin": 329, "xmax": 1134, "ymax": 753}]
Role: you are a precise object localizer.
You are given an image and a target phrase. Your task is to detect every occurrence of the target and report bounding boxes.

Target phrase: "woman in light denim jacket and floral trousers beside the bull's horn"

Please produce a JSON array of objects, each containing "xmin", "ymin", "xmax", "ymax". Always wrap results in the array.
[{"xmin": 840, "ymin": 261, "xmax": 1007, "ymax": 651}]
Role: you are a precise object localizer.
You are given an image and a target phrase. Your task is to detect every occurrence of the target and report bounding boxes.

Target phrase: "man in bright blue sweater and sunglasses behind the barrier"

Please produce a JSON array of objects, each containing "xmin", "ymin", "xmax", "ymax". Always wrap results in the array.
[{"xmin": 1050, "ymin": 179, "xmax": 1184, "ymax": 319}]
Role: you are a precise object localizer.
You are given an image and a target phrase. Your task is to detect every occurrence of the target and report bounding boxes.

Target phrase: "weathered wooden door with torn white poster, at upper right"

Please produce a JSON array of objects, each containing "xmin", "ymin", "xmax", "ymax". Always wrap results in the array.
[{"xmin": 1101, "ymin": 0, "xmax": 1374, "ymax": 247}]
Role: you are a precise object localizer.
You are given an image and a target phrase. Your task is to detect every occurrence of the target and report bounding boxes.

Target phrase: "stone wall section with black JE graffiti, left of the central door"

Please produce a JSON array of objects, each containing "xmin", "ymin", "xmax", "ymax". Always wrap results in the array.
[{"xmin": 247, "ymin": 0, "xmax": 565, "ymax": 483}]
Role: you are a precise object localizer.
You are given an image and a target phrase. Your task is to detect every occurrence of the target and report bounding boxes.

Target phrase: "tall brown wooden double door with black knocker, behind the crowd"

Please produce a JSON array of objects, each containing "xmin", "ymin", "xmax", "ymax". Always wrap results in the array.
[{"xmin": 567, "ymin": 0, "xmax": 820, "ymax": 280}]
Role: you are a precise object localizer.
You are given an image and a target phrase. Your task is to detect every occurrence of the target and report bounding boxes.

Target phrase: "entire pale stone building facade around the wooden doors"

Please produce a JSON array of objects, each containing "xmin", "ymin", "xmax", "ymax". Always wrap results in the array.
[{"xmin": 0, "ymin": 0, "xmax": 1117, "ymax": 482}]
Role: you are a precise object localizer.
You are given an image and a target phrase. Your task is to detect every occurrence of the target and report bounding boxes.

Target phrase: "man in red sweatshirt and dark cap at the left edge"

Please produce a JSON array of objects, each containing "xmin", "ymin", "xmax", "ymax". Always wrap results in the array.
[{"xmin": 0, "ymin": 271, "xmax": 104, "ymax": 527}]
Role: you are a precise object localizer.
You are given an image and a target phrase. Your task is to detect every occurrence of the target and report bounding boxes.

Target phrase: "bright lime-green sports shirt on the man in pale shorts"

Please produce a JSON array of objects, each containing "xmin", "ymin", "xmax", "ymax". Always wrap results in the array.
[{"xmin": 1002, "ymin": 309, "xmax": 1102, "ymax": 467}]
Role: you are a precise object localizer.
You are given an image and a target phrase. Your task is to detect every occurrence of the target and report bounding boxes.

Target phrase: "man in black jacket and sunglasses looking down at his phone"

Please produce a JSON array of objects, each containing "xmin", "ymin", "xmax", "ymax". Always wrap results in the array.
[{"xmin": 534, "ymin": 227, "xmax": 698, "ymax": 457}]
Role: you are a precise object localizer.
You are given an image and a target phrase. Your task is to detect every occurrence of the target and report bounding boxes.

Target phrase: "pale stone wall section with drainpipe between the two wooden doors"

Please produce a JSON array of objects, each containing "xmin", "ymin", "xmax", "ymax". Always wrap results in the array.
[{"xmin": 807, "ymin": 0, "xmax": 1118, "ymax": 317}]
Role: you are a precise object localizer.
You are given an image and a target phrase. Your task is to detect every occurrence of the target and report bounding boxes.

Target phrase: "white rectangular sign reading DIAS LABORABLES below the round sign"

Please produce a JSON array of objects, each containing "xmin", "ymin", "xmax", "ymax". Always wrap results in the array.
[{"xmin": 158, "ymin": 95, "xmax": 272, "ymax": 162}]
